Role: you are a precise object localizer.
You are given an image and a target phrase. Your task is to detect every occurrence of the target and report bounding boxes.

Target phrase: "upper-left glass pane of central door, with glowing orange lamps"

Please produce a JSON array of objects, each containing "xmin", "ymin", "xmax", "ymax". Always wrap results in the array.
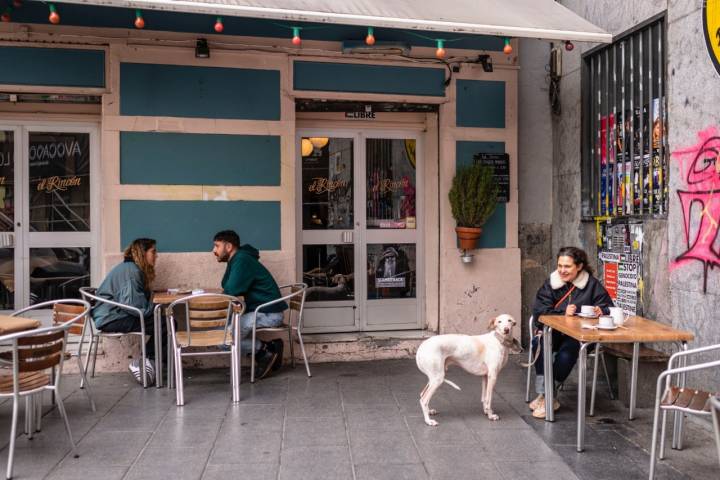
[{"xmin": 301, "ymin": 137, "xmax": 353, "ymax": 230}]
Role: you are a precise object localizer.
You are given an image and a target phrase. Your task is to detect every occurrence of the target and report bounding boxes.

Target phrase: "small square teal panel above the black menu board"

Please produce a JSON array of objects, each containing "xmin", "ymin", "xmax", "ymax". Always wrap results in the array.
[{"xmin": 455, "ymin": 80, "xmax": 505, "ymax": 128}]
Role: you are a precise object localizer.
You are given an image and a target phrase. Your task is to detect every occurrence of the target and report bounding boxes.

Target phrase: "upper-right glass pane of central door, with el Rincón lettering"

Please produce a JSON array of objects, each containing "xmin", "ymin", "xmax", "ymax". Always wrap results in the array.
[{"xmin": 366, "ymin": 138, "xmax": 416, "ymax": 229}]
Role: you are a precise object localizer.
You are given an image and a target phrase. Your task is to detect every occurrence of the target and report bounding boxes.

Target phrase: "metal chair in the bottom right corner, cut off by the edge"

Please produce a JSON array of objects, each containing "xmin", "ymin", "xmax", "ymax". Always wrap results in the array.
[{"xmin": 649, "ymin": 344, "xmax": 720, "ymax": 480}]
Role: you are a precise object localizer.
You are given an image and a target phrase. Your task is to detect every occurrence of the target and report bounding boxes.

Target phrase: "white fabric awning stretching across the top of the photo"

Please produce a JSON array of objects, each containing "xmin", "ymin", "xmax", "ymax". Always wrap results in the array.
[{"xmin": 57, "ymin": 0, "xmax": 612, "ymax": 43}]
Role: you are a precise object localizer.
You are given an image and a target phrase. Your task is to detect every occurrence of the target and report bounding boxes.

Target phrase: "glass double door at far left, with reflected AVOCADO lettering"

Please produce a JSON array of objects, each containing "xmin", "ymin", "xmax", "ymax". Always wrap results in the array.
[{"xmin": 0, "ymin": 125, "xmax": 97, "ymax": 310}]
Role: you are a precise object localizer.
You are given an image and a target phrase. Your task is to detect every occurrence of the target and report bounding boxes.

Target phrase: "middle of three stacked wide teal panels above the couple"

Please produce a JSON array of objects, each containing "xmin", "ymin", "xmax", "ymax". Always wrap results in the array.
[{"xmin": 120, "ymin": 132, "xmax": 280, "ymax": 185}]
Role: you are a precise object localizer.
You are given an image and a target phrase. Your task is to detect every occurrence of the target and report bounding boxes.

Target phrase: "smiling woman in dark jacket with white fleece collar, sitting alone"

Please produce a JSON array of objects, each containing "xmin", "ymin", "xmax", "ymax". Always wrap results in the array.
[{"xmin": 529, "ymin": 247, "xmax": 613, "ymax": 418}]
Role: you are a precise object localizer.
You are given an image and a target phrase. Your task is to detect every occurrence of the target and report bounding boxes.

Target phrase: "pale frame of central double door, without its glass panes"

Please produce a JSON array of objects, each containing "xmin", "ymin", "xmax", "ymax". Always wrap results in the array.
[{"xmin": 295, "ymin": 125, "xmax": 425, "ymax": 333}]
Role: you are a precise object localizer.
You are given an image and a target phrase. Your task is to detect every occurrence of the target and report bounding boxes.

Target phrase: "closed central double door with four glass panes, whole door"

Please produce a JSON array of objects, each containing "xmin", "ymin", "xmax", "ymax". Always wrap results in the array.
[{"xmin": 298, "ymin": 130, "xmax": 422, "ymax": 332}]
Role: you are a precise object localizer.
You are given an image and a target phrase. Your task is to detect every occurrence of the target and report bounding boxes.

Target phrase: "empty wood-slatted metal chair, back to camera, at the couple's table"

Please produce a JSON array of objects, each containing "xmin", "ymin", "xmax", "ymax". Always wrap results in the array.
[{"xmin": 167, "ymin": 293, "xmax": 245, "ymax": 407}]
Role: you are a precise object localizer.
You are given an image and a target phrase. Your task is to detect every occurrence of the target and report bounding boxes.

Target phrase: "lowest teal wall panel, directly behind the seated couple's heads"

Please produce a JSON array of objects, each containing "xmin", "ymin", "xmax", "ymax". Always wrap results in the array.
[{"xmin": 120, "ymin": 200, "xmax": 280, "ymax": 253}]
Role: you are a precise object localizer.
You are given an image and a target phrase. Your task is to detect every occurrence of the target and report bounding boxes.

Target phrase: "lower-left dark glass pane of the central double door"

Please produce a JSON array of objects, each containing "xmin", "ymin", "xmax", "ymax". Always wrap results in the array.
[{"xmin": 303, "ymin": 244, "xmax": 355, "ymax": 301}]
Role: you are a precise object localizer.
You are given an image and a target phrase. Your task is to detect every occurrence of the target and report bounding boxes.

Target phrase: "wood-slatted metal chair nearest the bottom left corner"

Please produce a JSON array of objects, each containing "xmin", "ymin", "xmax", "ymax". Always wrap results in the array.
[{"xmin": 0, "ymin": 300, "xmax": 90, "ymax": 479}]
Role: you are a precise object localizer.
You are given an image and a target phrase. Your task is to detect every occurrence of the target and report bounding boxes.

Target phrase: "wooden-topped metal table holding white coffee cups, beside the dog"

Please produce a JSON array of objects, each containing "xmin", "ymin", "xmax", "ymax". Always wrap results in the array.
[{"xmin": 539, "ymin": 315, "xmax": 694, "ymax": 452}]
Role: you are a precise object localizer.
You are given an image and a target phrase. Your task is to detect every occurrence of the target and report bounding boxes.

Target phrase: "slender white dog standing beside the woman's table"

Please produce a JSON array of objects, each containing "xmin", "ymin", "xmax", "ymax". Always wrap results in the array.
[{"xmin": 415, "ymin": 314, "xmax": 522, "ymax": 426}]
